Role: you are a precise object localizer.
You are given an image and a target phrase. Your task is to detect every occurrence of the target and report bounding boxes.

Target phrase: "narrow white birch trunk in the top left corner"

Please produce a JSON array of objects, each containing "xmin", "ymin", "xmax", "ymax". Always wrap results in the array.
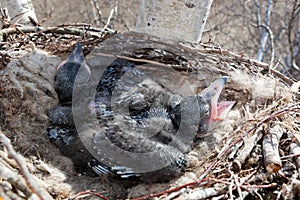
[{"xmin": 1, "ymin": 0, "xmax": 38, "ymax": 26}]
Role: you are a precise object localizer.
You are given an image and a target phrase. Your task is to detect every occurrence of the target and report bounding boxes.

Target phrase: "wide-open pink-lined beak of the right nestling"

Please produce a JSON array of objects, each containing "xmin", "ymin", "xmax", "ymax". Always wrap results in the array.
[{"xmin": 200, "ymin": 77, "xmax": 236, "ymax": 121}]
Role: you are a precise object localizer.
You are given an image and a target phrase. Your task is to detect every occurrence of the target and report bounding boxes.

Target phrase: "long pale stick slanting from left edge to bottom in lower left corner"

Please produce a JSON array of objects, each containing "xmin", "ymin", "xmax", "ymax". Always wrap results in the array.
[{"xmin": 0, "ymin": 131, "xmax": 53, "ymax": 200}]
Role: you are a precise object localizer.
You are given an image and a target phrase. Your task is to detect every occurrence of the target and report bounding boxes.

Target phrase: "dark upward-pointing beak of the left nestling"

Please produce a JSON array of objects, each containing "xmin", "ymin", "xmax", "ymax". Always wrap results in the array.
[{"xmin": 57, "ymin": 43, "xmax": 91, "ymax": 75}]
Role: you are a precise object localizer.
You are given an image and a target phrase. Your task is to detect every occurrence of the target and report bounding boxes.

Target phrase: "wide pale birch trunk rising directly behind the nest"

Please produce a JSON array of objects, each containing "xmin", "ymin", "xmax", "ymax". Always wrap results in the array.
[{"xmin": 136, "ymin": 0, "xmax": 212, "ymax": 42}]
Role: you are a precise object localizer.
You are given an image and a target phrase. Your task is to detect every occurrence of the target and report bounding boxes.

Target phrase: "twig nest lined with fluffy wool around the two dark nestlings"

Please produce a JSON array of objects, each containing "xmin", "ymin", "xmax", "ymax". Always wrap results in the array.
[{"xmin": 0, "ymin": 27, "xmax": 300, "ymax": 200}]
